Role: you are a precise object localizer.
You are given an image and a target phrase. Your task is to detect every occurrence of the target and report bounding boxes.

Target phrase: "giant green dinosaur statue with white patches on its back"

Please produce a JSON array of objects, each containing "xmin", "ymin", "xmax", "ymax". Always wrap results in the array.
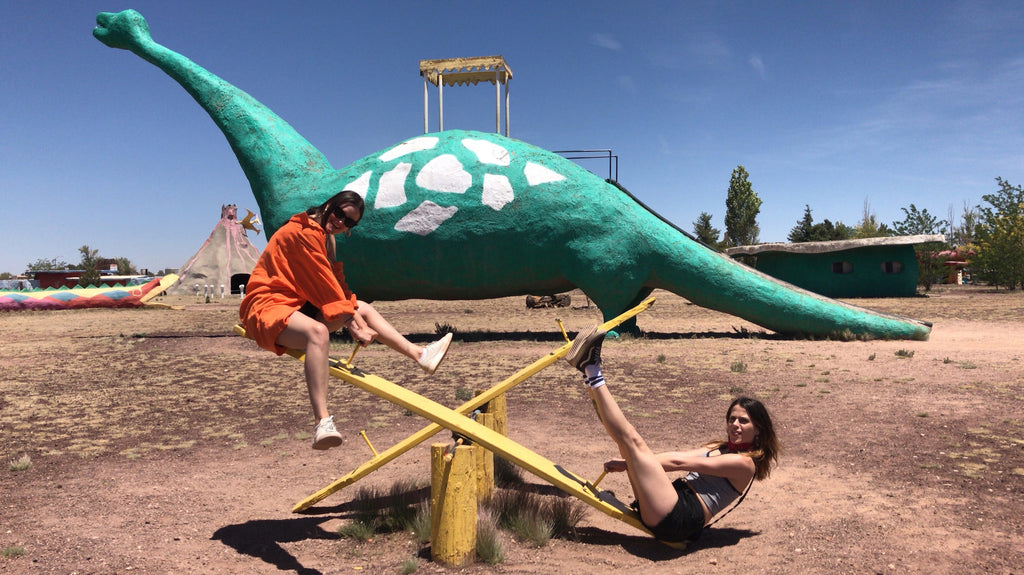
[{"xmin": 93, "ymin": 10, "xmax": 931, "ymax": 340}]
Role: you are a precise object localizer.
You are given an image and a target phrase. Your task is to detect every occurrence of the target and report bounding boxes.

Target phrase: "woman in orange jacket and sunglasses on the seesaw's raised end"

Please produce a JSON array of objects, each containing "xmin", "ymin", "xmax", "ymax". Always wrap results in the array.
[{"xmin": 239, "ymin": 190, "xmax": 452, "ymax": 449}]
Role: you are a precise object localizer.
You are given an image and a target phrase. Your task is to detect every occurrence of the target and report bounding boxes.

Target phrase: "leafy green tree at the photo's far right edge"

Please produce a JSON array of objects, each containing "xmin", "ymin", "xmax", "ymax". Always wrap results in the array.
[{"xmin": 971, "ymin": 178, "xmax": 1024, "ymax": 290}]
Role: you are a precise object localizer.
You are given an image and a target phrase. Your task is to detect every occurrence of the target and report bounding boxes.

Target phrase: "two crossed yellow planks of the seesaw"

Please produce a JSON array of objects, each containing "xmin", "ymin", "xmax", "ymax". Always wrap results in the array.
[{"xmin": 234, "ymin": 298, "xmax": 654, "ymax": 533}]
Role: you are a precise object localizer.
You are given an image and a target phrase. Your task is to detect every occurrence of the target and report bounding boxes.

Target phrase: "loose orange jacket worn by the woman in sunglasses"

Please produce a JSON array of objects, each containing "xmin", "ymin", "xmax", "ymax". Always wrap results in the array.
[{"xmin": 239, "ymin": 213, "xmax": 358, "ymax": 355}]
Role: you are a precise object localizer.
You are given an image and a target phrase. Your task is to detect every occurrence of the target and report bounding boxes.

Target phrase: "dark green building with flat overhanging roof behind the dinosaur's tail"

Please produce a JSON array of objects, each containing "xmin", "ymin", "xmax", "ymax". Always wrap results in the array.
[{"xmin": 724, "ymin": 234, "xmax": 945, "ymax": 298}]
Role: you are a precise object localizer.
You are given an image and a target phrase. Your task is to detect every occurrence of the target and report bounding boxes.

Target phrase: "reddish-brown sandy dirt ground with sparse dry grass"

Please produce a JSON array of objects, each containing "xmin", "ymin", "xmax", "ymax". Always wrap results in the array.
[{"xmin": 0, "ymin": 286, "xmax": 1024, "ymax": 575}]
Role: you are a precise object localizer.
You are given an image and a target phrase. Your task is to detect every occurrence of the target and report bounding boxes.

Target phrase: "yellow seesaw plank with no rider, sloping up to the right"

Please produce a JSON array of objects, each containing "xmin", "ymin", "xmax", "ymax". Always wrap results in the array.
[{"xmin": 288, "ymin": 298, "xmax": 654, "ymax": 513}]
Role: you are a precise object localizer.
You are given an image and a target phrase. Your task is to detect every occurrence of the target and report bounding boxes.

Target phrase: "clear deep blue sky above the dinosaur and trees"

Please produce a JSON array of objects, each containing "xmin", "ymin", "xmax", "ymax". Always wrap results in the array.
[{"xmin": 0, "ymin": 0, "xmax": 1024, "ymax": 273}]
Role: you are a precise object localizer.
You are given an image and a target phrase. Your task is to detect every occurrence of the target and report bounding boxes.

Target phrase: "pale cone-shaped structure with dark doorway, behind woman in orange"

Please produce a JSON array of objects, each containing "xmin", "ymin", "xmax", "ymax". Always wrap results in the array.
[{"xmin": 167, "ymin": 204, "xmax": 259, "ymax": 298}]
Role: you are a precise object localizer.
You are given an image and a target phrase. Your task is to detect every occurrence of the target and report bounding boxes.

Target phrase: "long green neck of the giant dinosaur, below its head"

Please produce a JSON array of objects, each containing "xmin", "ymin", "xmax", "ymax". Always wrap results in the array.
[{"xmin": 123, "ymin": 36, "xmax": 334, "ymax": 226}]
